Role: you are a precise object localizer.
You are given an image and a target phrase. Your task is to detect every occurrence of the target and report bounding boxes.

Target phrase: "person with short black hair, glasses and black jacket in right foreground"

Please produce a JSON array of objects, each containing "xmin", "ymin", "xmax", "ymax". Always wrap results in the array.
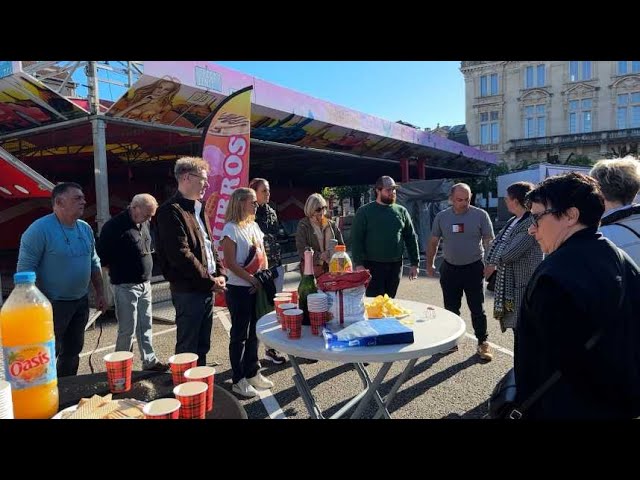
[{"xmin": 515, "ymin": 173, "xmax": 640, "ymax": 419}]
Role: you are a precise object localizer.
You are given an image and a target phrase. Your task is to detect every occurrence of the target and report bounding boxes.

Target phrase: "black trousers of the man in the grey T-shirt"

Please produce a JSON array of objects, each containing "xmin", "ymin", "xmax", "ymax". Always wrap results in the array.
[{"xmin": 440, "ymin": 260, "xmax": 488, "ymax": 343}]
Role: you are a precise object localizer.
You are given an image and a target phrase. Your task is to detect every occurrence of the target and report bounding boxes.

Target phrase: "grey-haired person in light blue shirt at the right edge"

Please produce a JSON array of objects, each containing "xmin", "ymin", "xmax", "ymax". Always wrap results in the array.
[{"xmin": 590, "ymin": 155, "xmax": 640, "ymax": 264}]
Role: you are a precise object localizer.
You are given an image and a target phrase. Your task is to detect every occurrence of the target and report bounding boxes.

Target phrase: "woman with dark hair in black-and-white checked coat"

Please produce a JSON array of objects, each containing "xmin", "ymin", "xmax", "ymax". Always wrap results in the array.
[{"xmin": 484, "ymin": 182, "xmax": 542, "ymax": 332}]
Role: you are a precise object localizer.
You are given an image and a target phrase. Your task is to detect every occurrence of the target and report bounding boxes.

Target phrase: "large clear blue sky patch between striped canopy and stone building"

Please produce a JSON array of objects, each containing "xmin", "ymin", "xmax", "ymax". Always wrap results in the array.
[{"xmin": 213, "ymin": 60, "xmax": 465, "ymax": 128}]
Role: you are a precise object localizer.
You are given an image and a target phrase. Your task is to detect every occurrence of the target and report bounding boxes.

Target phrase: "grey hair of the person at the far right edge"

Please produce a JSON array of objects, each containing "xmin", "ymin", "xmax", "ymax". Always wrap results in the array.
[{"xmin": 589, "ymin": 155, "xmax": 640, "ymax": 205}]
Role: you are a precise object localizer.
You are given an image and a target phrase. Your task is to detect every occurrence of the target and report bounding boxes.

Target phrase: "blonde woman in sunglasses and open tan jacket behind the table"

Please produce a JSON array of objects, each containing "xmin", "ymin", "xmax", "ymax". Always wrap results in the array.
[{"xmin": 296, "ymin": 193, "xmax": 344, "ymax": 277}]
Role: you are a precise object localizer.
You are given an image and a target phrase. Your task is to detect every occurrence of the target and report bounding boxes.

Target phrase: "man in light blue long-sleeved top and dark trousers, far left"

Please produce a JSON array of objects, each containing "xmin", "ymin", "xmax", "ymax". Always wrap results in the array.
[{"xmin": 17, "ymin": 182, "xmax": 106, "ymax": 377}]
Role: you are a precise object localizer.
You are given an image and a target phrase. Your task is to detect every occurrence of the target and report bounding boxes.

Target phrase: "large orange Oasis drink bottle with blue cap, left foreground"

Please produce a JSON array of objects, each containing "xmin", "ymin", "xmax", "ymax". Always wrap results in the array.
[{"xmin": 0, "ymin": 272, "xmax": 58, "ymax": 418}]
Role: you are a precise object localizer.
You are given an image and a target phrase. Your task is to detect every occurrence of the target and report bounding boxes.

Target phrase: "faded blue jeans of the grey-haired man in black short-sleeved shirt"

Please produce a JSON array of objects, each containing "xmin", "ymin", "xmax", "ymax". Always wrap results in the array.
[{"xmin": 111, "ymin": 282, "xmax": 158, "ymax": 368}]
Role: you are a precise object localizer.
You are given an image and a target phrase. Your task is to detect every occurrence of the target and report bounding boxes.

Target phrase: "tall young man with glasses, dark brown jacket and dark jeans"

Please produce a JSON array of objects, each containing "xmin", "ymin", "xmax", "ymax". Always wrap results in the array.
[{"xmin": 156, "ymin": 157, "xmax": 226, "ymax": 366}]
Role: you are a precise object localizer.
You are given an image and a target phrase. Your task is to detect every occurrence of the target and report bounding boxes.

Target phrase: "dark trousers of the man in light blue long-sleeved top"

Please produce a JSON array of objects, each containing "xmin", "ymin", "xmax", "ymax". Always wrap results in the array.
[{"xmin": 51, "ymin": 295, "xmax": 89, "ymax": 377}]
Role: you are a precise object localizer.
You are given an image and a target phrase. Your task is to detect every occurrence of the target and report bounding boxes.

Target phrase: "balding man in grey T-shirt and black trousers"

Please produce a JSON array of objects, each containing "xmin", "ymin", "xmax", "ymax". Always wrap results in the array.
[{"xmin": 426, "ymin": 183, "xmax": 493, "ymax": 361}]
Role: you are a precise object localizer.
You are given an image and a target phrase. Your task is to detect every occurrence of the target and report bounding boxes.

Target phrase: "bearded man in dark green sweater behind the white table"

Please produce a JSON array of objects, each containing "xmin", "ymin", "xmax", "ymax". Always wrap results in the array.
[{"xmin": 351, "ymin": 175, "xmax": 420, "ymax": 298}]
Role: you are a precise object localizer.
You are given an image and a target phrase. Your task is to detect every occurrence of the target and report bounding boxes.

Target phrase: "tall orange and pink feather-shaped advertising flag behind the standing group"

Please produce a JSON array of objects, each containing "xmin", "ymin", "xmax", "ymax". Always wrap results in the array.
[{"xmin": 202, "ymin": 86, "xmax": 253, "ymax": 257}]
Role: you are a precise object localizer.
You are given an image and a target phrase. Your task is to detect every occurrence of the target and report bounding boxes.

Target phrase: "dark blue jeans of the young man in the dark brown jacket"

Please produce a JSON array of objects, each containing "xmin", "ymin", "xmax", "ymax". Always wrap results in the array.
[{"xmin": 171, "ymin": 290, "xmax": 213, "ymax": 366}]
